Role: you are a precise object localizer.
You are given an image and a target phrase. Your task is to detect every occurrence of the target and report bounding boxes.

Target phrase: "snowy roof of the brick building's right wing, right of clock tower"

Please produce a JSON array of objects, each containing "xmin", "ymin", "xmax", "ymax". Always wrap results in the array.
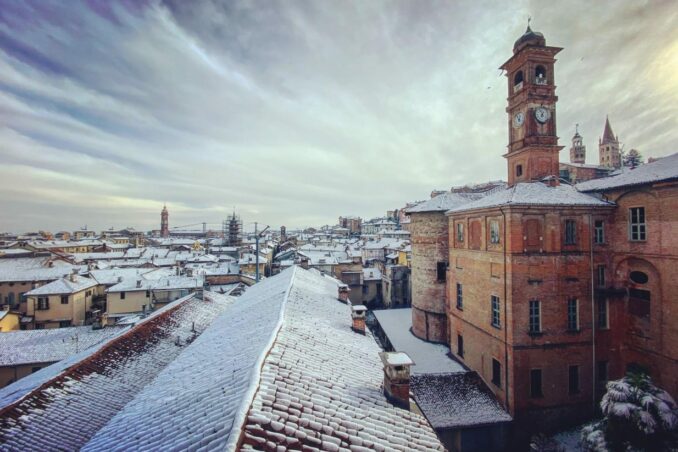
[{"xmin": 577, "ymin": 152, "xmax": 678, "ymax": 192}]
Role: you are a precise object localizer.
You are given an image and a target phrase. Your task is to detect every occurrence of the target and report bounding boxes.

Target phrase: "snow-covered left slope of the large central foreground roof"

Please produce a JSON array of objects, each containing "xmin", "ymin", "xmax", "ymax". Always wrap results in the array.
[{"xmin": 83, "ymin": 284, "xmax": 272, "ymax": 450}]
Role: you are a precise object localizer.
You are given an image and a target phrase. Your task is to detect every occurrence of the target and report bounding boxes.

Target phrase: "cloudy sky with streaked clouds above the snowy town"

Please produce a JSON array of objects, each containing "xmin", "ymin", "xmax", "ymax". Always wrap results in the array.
[{"xmin": 0, "ymin": 0, "xmax": 678, "ymax": 232}]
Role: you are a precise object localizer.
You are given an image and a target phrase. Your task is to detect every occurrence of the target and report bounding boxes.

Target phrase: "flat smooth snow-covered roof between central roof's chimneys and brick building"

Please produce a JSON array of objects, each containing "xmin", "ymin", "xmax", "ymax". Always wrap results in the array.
[{"xmin": 372, "ymin": 308, "xmax": 466, "ymax": 374}]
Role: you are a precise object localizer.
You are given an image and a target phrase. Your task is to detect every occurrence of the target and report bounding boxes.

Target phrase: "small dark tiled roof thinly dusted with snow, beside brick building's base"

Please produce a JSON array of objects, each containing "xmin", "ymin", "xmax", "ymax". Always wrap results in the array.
[{"xmin": 410, "ymin": 372, "xmax": 512, "ymax": 429}]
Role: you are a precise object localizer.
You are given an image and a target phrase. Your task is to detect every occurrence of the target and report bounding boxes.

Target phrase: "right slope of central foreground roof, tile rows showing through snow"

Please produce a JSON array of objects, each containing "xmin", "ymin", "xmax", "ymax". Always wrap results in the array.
[{"xmin": 243, "ymin": 268, "xmax": 442, "ymax": 450}]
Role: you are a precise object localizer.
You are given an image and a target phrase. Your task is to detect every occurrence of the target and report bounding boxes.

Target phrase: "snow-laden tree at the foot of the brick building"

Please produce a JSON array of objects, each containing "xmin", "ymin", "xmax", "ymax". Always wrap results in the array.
[{"xmin": 581, "ymin": 373, "xmax": 678, "ymax": 451}]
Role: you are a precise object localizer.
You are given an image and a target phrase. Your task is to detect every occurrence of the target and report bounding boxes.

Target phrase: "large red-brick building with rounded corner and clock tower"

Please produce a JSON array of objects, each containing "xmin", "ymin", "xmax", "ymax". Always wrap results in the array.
[{"xmin": 409, "ymin": 23, "xmax": 678, "ymax": 436}]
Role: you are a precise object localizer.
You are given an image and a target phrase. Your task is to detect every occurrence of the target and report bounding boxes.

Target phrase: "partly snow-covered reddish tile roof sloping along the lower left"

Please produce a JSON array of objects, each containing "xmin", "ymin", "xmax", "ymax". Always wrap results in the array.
[{"xmin": 0, "ymin": 297, "xmax": 231, "ymax": 450}]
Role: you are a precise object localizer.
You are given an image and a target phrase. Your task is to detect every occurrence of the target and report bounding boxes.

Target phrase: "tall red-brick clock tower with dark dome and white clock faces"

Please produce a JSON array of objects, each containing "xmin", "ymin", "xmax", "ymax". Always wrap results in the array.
[{"xmin": 500, "ymin": 25, "xmax": 562, "ymax": 186}]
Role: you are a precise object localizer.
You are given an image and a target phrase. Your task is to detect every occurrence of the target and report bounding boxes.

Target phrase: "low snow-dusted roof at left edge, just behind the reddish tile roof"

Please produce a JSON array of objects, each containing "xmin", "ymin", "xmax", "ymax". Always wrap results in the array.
[{"xmin": 0, "ymin": 324, "xmax": 124, "ymax": 366}]
